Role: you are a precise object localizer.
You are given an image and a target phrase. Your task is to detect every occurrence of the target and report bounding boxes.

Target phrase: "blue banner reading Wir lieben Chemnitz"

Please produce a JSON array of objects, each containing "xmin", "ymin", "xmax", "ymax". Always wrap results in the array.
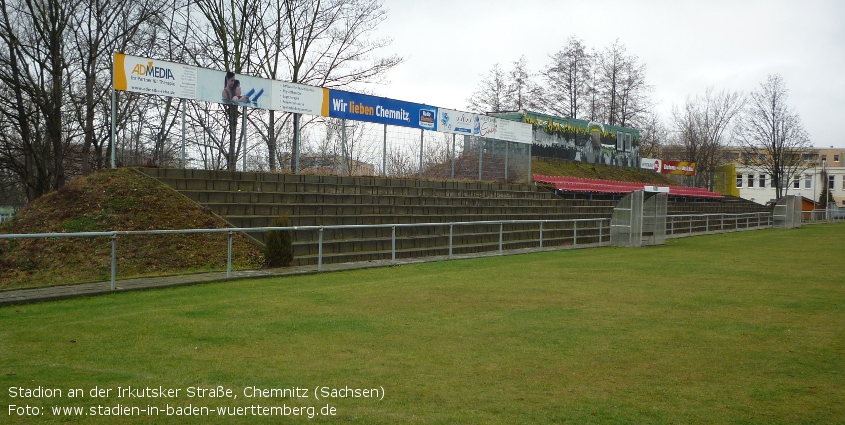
[{"xmin": 329, "ymin": 90, "xmax": 437, "ymax": 131}]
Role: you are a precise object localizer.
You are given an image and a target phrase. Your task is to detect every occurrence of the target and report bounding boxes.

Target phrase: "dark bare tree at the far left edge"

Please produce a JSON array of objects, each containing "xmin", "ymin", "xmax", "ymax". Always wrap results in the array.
[{"xmin": 0, "ymin": 0, "xmax": 77, "ymax": 200}]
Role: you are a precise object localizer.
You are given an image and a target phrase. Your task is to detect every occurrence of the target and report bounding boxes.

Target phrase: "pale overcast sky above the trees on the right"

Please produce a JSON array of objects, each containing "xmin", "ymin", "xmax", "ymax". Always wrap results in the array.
[{"xmin": 374, "ymin": 0, "xmax": 845, "ymax": 148}]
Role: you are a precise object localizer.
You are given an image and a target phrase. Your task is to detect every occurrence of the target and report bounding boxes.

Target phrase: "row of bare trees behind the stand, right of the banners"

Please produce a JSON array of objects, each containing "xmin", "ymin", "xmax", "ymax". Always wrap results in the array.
[{"xmin": 467, "ymin": 36, "xmax": 813, "ymax": 197}]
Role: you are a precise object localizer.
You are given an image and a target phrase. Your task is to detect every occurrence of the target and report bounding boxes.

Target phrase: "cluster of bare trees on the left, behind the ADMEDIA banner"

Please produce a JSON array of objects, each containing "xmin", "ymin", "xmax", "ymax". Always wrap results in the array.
[{"xmin": 0, "ymin": 0, "xmax": 403, "ymax": 205}]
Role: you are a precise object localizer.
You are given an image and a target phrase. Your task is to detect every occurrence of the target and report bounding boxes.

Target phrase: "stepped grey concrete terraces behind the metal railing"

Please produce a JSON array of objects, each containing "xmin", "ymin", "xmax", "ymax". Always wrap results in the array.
[{"xmin": 139, "ymin": 168, "xmax": 772, "ymax": 265}]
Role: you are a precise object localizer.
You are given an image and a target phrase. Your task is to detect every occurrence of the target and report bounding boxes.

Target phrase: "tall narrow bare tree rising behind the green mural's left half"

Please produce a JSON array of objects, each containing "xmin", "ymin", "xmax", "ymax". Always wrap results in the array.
[{"xmin": 543, "ymin": 36, "xmax": 593, "ymax": 118}]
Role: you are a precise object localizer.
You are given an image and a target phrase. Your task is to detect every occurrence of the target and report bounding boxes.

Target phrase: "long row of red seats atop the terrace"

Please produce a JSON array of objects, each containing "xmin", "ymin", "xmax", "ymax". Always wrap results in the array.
[{"xmin": 534, "ymin": 174, "xmax": 724, "ymax": 198}]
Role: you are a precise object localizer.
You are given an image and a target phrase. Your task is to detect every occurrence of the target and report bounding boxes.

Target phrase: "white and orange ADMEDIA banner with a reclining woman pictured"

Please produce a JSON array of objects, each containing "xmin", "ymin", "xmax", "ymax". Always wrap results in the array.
[{"xmin": 114, "ymin": 53, "xmax": 329, "ymax": 116}]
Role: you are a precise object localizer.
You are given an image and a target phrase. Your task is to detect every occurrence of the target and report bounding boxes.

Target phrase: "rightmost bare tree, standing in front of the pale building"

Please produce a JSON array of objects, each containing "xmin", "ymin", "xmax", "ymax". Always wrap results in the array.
[{"xmin": 737, "ymin": 74, "xmax": 813, "ymax": 199}]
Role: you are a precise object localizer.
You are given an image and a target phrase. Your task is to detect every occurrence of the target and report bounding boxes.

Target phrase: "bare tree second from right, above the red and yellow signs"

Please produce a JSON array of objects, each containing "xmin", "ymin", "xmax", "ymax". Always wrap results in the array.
[{"xmin": 672, "ymin": 87, "xmax": 744, "ymax": 190}]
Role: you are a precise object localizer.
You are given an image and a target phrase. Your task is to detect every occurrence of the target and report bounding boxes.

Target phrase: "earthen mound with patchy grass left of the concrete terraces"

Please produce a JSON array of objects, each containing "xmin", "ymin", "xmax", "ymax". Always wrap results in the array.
[{"xmin": 0, "ymin": 169, "xmax": 262, "ymax": 289}]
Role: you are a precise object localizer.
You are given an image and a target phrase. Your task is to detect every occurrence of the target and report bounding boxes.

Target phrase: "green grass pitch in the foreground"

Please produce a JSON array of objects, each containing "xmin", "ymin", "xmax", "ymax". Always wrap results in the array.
[{"xmin": 0, "ymin": 224, "xmax": 845, "ymax": 424}]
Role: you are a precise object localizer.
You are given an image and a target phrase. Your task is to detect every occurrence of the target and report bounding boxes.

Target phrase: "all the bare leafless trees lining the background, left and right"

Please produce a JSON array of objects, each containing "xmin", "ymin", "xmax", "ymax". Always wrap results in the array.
[{"xmin": 0, "ymin": 4, "xmax": 809, "ymax": 205}]
